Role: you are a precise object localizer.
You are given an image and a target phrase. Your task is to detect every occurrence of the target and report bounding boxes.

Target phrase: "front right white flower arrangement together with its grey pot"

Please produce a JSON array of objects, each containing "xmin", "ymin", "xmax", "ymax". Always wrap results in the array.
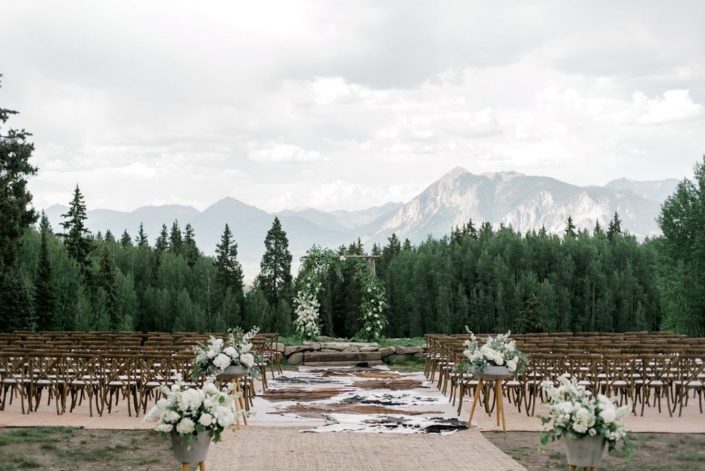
[{"xmin": 541, "ymin": 374, "xmax": 631, "ymax": 468}]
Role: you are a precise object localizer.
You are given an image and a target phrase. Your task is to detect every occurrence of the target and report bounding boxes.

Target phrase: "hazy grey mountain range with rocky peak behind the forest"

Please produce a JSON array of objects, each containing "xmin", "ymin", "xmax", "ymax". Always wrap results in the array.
[{"xmin": 46, "ymin": 168, "xmax": 678, "ymax": 279}]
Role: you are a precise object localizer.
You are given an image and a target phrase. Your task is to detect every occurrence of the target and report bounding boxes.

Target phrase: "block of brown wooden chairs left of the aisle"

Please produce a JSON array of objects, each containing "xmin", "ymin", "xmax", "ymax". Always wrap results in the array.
[{"xmin": 0, "ymin": 332, "xmax": 283, "ymax": 416}]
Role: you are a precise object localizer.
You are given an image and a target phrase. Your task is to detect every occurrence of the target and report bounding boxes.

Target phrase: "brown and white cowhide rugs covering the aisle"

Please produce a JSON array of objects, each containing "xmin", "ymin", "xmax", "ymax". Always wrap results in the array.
[{"xmin": 254, "ymin": 367, "xmax": 467, "ymax": 434}]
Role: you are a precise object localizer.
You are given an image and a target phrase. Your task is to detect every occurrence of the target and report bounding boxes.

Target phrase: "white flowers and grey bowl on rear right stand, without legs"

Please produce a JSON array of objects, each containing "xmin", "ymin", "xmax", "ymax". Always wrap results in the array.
[{"xmin": 459, "ymin": 332, "xmax": 528, "ymax": 379}]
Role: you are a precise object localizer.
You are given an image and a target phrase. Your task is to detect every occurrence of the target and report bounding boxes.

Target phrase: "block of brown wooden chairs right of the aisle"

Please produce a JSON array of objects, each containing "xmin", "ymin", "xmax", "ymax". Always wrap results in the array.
[{"xmin": 425, "ymin": 333, "xmax": 705, "ymax": 415}]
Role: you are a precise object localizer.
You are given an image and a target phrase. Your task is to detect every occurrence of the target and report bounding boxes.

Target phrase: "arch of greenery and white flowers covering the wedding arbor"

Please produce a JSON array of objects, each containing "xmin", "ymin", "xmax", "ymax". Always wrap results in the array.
[{"xmin": 294, "ymin": 245, "xmax": 387, "ymax": 340}]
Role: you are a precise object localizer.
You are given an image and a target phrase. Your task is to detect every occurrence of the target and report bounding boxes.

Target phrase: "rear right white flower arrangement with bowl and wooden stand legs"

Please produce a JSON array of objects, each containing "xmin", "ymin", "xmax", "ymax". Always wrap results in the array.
[{"xmin": 457, "ymin": 330, "xmax": 528, "ymax": 431}]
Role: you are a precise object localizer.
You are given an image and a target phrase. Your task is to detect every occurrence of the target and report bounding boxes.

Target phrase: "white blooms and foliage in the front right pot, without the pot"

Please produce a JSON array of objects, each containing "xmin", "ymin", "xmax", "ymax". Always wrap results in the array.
[{"xmin": 541, "ymin": 374, "xmax": 631, "ymax": 454}]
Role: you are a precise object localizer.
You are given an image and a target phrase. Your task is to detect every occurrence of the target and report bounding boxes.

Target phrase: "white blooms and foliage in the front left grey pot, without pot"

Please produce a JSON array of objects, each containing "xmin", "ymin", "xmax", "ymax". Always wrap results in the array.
[{"xmin": 144, "ymin": 377, "xmax": 235, "ymax": 442}]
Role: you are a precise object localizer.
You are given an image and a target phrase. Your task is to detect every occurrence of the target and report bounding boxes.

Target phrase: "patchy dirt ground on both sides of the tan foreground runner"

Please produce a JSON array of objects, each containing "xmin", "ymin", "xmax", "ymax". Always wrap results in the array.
[{"xmin": 0, "ymin": 427, "xmax": 705, "ymax": 471}]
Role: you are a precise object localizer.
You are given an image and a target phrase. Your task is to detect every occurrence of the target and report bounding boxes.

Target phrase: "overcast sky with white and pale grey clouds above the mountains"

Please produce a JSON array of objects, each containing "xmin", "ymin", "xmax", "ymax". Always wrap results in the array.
[{"xmin": 0, "ymin": 0, "xmax": 705, "ymax": 210}]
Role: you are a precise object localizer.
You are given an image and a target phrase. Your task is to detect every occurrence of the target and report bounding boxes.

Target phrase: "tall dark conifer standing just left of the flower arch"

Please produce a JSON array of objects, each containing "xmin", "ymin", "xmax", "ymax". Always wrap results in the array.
[{"xmin": 257, "ymin": 217, "xmax": 293, "ymax": 306}]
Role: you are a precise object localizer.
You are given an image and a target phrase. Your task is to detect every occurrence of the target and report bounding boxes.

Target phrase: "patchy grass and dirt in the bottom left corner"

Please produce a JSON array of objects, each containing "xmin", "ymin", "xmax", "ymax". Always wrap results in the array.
[{"xmin": 0, "ymin": 427, "xmax": 177, "ymax": 471}]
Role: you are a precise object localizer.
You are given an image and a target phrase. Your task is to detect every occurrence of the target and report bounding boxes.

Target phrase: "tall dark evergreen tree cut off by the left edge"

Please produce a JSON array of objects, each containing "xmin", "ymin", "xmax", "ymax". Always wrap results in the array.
[{"xmin": 0, "ymin": 75, "xmax": 37, "ymax": 273}]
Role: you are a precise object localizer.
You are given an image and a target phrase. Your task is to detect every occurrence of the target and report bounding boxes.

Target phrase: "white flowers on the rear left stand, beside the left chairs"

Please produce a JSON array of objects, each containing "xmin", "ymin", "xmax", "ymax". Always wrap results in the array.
[{"xmin": 193, "ymin": 327, "xmax": 259, "ymax": 378}]
